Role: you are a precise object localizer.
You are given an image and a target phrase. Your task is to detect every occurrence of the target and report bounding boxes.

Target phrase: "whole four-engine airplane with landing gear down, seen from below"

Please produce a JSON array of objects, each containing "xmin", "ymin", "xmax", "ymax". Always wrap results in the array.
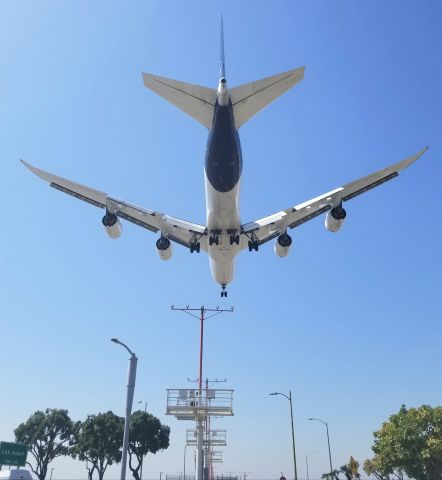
[{"xmin": 21, "ymin": 19, "xmax": 428, "ymax": 297}]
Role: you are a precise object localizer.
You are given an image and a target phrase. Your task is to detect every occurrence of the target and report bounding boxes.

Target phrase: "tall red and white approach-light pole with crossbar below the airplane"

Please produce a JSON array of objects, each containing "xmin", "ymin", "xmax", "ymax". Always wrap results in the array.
[{"xmin": 171, "ymin": 305, "xmax": 233, "ymax": 480}]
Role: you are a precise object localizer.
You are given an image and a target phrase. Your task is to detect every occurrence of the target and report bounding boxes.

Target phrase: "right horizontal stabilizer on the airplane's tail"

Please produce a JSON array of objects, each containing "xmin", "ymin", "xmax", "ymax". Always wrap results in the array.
[{"xmin": 230, "ymin": 67, "xmax": 305, "ymax": 128}]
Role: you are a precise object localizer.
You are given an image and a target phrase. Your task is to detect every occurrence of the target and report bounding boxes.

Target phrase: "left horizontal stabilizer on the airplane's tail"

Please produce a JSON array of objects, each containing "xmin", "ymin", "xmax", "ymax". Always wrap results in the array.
[{"xmin": 143, "ymin": 73, "xmax": 216, "ymax": 129}]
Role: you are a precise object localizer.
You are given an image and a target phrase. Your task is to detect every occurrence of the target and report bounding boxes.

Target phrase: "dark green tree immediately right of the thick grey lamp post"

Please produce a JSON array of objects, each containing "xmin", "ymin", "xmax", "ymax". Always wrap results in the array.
[{"xmin": 129, "ymin": 410, "xmax": 170, "ymax": 480}]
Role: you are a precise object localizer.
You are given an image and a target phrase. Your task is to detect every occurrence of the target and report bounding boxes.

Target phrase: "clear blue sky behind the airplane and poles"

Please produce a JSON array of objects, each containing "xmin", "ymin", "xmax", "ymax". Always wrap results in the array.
[{"xmin": 0, "ymin": 0, "xmax": 442, "ymax": 479}]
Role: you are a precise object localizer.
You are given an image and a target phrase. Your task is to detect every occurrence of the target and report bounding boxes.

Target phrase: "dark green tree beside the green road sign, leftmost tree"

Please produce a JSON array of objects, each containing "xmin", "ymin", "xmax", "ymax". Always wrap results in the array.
[{"xmin": 14, "ymin": 408, "xmax": 76, "ymax": 480}]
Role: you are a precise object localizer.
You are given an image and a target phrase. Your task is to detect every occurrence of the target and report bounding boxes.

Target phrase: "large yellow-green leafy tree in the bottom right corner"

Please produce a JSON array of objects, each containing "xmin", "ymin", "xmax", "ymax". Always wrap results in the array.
[{"xmin": 364, "ymin": 405, "xmax": 442, "ymax": 480}]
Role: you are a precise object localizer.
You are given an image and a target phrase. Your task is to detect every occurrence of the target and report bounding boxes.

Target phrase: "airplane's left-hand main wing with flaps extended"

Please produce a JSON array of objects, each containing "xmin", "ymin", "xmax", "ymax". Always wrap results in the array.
[{"xmin": 21, "ymin": 160, "xmax": 207, "ymax": 250}]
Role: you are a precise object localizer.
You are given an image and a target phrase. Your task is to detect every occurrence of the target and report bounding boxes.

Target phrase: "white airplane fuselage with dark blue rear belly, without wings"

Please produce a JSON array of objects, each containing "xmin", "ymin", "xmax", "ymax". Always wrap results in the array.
[{"xmin": 204, "ymin": 78, "xmax": 242, "ymax": 287}]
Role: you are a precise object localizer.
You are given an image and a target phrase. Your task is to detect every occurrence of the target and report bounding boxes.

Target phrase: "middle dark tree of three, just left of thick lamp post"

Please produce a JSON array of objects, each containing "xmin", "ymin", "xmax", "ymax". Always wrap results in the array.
[{"xmin": 71, "ymin": 411, "xmax": 124, "ymax": 480}]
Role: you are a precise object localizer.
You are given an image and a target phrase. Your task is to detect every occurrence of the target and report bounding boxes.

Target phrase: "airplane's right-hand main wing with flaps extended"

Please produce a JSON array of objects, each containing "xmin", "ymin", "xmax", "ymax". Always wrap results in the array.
[{"xmin": 241, "ymin": 147, "xmax": 428, "ymax": 249}]
